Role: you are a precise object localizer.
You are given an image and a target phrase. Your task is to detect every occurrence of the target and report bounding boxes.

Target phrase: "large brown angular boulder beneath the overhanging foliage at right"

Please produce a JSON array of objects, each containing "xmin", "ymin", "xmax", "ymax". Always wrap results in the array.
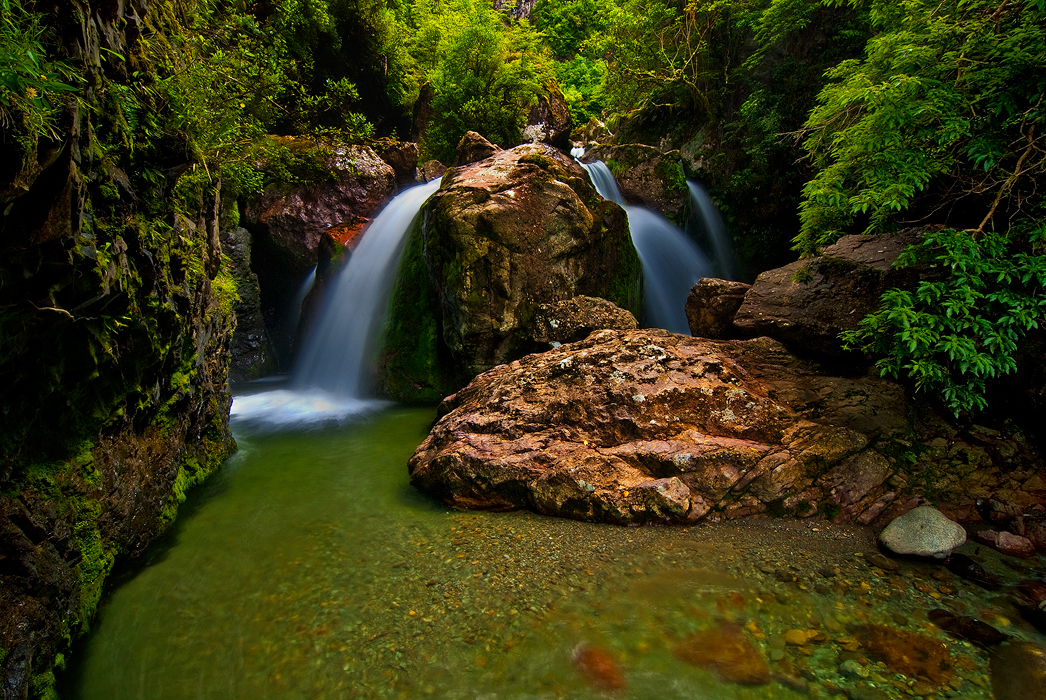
[{"xmin": 733, "ymin": 231, "xmax": 918, "ymax": 356}]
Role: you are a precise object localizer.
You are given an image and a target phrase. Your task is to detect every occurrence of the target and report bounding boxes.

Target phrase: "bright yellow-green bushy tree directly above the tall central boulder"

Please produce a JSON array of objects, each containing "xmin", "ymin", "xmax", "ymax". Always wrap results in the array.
[{"xmin": 401, "ymin": 0, "xmax": 552, "ymax": 162}]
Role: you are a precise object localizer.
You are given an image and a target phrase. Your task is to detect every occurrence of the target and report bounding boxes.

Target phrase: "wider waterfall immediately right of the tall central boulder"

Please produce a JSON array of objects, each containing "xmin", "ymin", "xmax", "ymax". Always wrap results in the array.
[{"xmin": 582, "ymin": 160, "xmax": 711, "ymax": 335}]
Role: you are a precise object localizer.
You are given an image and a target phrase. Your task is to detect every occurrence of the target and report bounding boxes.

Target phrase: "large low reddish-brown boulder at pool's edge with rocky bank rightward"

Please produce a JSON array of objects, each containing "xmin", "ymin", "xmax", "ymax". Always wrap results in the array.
[{"xmin": 409, "ymin": 331, "xmax": 1046, "ymax": 524}]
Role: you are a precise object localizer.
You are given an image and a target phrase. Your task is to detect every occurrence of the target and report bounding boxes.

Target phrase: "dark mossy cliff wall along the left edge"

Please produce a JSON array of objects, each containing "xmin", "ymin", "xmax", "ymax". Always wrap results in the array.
[{"xmin": 0, "ymin": 0, "xmax": 236, "ymax": 698}]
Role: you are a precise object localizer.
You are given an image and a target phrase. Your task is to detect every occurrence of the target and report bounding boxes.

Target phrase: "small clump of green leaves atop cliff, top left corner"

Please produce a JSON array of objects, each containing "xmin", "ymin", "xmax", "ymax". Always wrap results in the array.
[{"xmin": 0, "ymin": 0, "xmax": 79, "ymax": 151}]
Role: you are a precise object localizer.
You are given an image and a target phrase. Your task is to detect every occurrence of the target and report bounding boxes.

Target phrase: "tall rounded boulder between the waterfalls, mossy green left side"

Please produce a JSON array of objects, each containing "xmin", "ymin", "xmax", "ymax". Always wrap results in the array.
[{"xmin": 384, "ymin": 143, "xmax": 641, "ymax": 401}]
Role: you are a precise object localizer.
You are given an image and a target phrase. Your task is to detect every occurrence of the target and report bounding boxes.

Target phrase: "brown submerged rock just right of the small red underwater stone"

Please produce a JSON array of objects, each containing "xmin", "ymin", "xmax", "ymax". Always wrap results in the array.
[{"xmin": 672, "ymin": 624, "xmax": 771, "ymax": 685}]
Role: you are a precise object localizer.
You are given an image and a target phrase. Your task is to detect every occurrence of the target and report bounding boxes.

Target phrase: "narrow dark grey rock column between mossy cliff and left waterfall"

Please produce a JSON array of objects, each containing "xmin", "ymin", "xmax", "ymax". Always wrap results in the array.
[{"xmin": 222, "ymin": 228, "xmax": 276, "ymax": 381}]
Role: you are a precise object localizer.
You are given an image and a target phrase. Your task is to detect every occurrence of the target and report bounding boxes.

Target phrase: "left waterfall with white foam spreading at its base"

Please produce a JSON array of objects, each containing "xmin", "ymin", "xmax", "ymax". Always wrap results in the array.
[{"xmin": 230, "ymin": 180, "xmax": 439, "ymax": 426}]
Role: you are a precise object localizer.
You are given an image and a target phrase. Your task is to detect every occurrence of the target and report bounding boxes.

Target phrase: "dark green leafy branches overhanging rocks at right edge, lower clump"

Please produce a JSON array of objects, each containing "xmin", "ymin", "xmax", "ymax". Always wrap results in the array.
[{"xmin": 843, "ymin": 229, "xmax": 1046, "ymax": 414}]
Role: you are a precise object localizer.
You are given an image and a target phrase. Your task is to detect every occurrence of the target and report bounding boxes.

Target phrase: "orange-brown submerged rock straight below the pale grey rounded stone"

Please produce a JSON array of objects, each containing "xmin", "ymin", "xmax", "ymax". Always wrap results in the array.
[{"xmin": 855, "ymin": 625, "xmax": 954, "ymax": 685}]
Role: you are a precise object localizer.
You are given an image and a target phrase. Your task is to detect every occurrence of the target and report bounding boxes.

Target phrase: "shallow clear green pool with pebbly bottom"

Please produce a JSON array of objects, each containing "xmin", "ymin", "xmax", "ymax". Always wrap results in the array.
[{"xmin": 67, "ymin": 408, "xmax": 1033, "ymax": 700}]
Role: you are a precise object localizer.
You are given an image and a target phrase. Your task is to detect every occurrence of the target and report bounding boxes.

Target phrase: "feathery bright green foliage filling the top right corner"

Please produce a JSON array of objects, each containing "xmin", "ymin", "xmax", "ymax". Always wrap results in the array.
[{"xmin": 796, "ymin": 0, "xmax": 1046, "ymax": 253}]
